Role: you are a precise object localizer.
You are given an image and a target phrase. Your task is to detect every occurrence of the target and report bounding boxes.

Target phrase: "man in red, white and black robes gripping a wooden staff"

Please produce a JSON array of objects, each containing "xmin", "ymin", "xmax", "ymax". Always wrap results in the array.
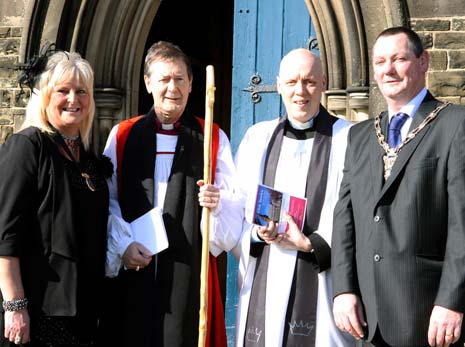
[{"xmin": 101, "ymin": 42, "xmax": 240, "ymax": 347}]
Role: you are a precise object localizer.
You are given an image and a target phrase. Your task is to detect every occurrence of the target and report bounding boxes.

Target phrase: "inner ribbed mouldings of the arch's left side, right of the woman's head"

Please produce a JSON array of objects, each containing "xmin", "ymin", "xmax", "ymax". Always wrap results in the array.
[{"xmin": 76, "ymin": 0, "xmax": 160, "ymax": 148}]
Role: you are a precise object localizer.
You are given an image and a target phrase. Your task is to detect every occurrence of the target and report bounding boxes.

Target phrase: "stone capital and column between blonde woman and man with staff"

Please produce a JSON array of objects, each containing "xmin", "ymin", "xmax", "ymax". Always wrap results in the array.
[{"xmin": 92, "ymin": 88, "xmax": 124, "ymax": 153}]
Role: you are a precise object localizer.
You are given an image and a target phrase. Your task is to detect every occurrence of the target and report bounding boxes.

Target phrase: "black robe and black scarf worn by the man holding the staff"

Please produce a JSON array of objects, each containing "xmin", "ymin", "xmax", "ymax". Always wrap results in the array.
[{"xmin": 101, "ymin": 110, "xmax": 208, "ymax": 347}]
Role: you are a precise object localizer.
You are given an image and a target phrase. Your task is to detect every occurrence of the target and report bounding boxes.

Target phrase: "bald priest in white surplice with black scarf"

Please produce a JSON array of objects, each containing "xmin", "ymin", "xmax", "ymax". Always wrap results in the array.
[{"xmin": 235, "ymin": 49, "xmax": 355, "ymax": 347}]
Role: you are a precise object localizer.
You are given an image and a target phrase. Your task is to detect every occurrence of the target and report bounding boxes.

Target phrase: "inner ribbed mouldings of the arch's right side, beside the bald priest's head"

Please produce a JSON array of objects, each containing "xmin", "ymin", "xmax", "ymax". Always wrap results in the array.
[{"xmin": 306, "ymin": 0, "xmax": 369, "ymax": 120}]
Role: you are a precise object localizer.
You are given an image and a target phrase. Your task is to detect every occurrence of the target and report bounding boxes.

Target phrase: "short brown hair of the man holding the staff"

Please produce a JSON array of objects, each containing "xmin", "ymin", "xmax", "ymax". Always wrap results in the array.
[{"xmin": 144, "ymin": 41, "xmax": 192, "ymax": 79}]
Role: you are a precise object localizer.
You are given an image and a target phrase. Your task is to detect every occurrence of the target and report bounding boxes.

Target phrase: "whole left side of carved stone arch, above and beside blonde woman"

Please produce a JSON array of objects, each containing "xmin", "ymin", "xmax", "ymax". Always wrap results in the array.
[{"xmin": 20, "ymin": 0, "xmax": 160, "ymax": 150}]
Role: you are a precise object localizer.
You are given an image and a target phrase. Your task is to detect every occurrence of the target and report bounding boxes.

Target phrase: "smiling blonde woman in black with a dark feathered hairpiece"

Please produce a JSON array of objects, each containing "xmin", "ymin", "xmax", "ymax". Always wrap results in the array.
[{"xmin": 0, "ymin": 52, "xmax": 112, "ymax": 347}]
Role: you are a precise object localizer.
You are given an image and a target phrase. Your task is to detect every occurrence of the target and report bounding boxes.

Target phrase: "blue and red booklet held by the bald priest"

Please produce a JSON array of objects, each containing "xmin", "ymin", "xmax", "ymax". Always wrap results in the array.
[{"xmin": 253, "ymin": 184, "xmax": 307, "ymax": 233}]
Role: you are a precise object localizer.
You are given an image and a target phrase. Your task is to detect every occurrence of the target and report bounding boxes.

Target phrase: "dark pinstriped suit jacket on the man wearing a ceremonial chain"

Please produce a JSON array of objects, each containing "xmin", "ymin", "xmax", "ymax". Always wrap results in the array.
[{"xmin": 332, "ymin": 93, "xmax": 465, "ymax": 346}]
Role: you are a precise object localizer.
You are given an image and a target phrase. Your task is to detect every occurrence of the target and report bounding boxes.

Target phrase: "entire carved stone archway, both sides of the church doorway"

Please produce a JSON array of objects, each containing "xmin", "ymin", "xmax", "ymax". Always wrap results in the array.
[{"xmin": 20, "ymin": 0, "xmax": 408, "ymax": 148}]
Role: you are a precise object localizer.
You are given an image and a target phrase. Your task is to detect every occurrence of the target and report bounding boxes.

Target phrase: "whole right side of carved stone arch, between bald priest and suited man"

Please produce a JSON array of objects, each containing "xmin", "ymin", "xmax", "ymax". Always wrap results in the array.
[{"xmin": 305, "ymin": 0, "xmax": 408, "ymax": 121}]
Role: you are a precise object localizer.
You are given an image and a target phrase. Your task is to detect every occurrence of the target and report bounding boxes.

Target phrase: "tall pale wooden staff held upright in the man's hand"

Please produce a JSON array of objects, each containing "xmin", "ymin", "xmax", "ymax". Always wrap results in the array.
[{"xmin": 198, "ymin": 65, "xmax": 215, "ymax": 347}]
